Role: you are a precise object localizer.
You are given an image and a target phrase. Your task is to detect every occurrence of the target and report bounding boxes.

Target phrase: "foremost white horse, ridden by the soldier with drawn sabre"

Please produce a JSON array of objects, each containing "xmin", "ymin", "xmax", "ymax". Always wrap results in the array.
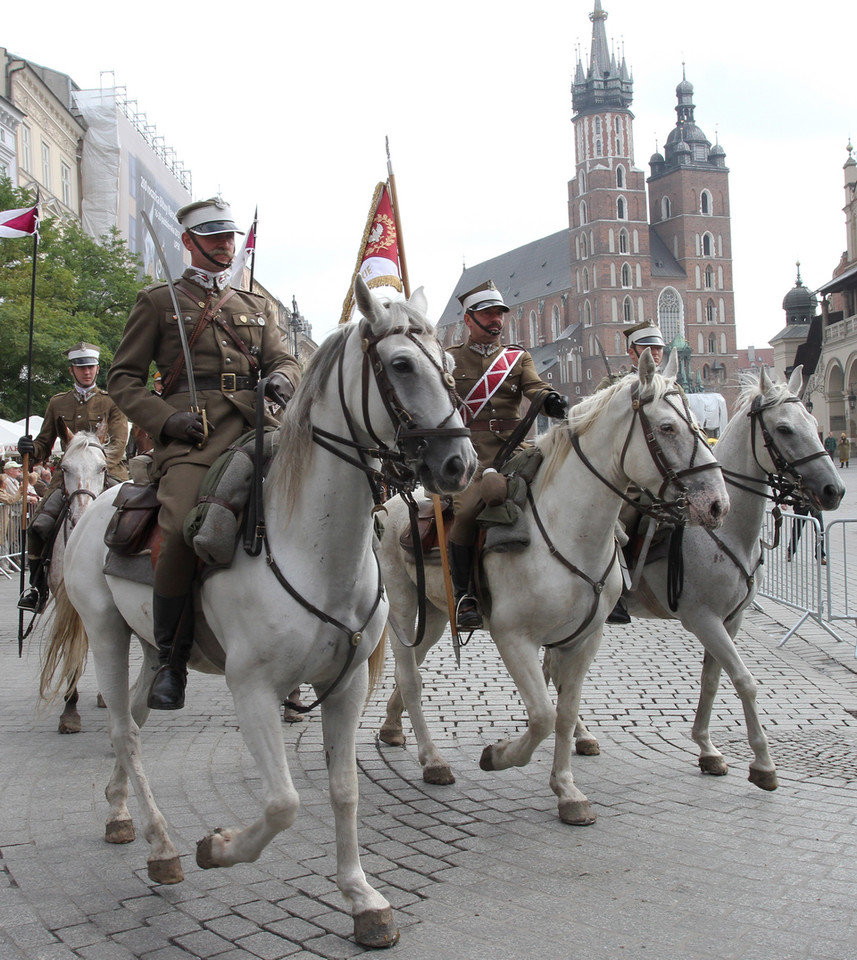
[{"xmin": 51, "ymin": 278, "xmax": 476, "ymax": 947}]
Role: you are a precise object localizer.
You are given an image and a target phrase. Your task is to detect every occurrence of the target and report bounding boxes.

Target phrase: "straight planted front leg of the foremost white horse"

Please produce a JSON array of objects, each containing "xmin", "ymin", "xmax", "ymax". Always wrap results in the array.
[{"xmin": 321, "ymin": 664, "xmax": 399, "ymax": 948}]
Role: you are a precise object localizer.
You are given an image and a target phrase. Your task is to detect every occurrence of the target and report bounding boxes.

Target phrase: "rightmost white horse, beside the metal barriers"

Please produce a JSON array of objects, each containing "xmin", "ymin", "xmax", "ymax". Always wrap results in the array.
[{"xmin": 596, "ymin": 367, "xmax": 845, "ymax": 790}]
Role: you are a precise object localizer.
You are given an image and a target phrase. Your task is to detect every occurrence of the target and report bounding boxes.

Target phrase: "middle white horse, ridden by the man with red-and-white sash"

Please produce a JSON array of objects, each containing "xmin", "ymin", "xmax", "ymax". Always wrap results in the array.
[{"xmin": 380, "ymin": 351, "xmax": 728, "ymax": 824}]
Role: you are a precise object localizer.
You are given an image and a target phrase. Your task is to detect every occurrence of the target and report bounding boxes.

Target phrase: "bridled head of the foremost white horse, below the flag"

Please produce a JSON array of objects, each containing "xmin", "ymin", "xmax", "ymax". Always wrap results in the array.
[{"xmin": 342, "ymin": 276, "xmax": 477, "ymax": 493}]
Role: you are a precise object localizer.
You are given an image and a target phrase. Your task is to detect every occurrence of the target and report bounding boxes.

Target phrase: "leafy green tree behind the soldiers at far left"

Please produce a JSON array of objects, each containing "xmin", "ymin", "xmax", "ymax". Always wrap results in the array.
[{"xmin": 0, "ymin": 180, "xmax": 145, "ymax": 420}]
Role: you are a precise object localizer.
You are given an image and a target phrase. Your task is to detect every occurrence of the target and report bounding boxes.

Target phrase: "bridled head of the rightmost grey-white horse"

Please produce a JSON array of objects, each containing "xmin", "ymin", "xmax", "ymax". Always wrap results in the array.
[{"xmin": 739, "ymin": 365, "xmax": 845, "ymax": 510}]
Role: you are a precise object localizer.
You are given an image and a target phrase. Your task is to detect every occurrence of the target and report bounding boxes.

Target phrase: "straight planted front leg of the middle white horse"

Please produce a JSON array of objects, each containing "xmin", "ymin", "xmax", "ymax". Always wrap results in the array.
[{"xmin": 550, "ymin": 629, "xmax": 601, "ymax": 826}]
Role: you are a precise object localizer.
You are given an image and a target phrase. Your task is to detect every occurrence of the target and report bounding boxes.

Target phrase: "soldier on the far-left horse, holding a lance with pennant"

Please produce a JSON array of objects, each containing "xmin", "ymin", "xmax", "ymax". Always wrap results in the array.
[{"xmin": 18, "ymin": 342, "xmax": 128, "ymax": 613}]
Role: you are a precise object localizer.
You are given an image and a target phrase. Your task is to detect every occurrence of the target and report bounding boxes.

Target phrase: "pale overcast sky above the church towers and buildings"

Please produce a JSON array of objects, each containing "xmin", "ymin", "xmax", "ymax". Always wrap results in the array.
[{"xmin": 5, "ymin": 0, "xmax": 857, "ymax": 347}]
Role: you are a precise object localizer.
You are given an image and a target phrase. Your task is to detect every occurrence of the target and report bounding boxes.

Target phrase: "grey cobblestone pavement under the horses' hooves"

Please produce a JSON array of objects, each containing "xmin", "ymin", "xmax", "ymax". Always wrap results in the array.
[{"xmin": 0, "ymin": 478, "xmax": 857, "ymax": 960}]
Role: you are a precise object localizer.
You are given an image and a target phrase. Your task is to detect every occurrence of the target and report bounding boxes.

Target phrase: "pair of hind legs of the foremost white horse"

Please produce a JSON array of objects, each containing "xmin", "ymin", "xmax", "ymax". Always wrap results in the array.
[{"xmin": 90, "ymin": 628, "xmax": 184, "ymax": 883}]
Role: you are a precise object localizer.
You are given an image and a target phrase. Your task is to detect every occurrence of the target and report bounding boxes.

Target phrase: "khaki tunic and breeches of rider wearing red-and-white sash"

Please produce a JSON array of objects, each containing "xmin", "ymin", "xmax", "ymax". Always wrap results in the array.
[{"xmin": 449, "ymin": 344, "xmax": 553, "ymax": 544}]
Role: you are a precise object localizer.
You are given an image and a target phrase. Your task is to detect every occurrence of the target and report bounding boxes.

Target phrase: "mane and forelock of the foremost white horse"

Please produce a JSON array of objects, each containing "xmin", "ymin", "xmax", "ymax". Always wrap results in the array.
[{"xmin": 269, "ymin": 300, "xmax": 435, "ymax": 510}]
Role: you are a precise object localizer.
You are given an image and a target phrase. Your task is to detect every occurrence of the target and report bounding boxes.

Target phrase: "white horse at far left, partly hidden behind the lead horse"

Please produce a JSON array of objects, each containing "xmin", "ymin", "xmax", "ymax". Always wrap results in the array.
[{"xmin": 39, "ymin": 420, "xmax": 108, "ymax": 733}]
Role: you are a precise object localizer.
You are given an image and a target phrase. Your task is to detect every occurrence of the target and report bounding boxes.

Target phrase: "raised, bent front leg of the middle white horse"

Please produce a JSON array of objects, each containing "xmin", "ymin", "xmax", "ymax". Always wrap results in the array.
[{"xmin": 479, "ymin": 627, "xmax": 556, "ymax": 770}]
